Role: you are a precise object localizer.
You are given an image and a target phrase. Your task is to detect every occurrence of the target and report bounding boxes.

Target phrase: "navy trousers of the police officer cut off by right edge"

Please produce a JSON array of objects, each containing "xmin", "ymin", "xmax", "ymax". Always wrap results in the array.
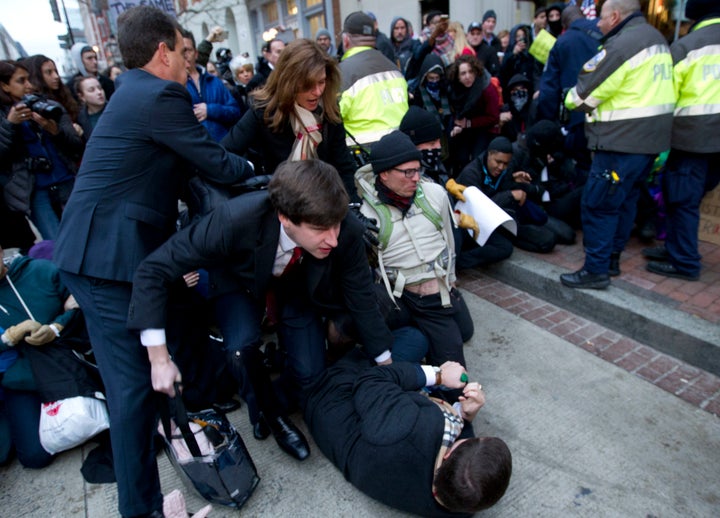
[{"xmin": 663, "ymin": 149, "xmax": 720, "ymax": 275}]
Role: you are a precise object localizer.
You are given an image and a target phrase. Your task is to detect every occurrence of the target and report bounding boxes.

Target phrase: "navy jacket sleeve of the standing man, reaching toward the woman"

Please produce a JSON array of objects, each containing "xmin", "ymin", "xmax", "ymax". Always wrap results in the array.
[{"xmin": 148, "ymin": 82, "xmax": 254, "ymax": 184}]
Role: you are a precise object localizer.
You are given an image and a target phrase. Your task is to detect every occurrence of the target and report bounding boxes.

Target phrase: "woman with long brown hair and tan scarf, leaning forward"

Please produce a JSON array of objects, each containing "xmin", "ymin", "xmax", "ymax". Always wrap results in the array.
[{"xmin": 220, "ymin": 39, "xmax": 357, "ymax": 199}]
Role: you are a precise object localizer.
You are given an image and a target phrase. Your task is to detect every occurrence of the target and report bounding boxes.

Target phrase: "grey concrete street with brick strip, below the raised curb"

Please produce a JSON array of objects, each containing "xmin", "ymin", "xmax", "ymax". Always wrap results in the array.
[{"xmin": 0, "ymin": 282, "xmax": 720, "ymax": 518}]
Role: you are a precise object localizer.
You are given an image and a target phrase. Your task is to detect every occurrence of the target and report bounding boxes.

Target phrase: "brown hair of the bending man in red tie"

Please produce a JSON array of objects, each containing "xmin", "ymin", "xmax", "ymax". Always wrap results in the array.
[{"xmin": 268, "ymin": 160, "xmax": 350, "ymax": 228}]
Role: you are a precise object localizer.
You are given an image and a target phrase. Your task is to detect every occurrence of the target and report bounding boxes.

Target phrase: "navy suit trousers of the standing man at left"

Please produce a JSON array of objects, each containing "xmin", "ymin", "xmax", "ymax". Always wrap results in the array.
[{"xmin": 60, "ymin": 270, "xmax": 162, "ymax": 516}]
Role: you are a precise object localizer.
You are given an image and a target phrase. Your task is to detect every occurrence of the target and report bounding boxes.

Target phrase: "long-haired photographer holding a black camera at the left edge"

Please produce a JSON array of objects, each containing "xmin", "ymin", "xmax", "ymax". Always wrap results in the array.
[{"xmin": 0, "ymin": 61, "xmax": 84, "ymax": 239}]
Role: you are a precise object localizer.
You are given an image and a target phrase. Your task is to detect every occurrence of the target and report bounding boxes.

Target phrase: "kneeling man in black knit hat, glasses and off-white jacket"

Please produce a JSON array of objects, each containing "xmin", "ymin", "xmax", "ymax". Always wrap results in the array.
[{"xmin": 355, "ymin": 132, "xmax": 477, "ymax": 365}]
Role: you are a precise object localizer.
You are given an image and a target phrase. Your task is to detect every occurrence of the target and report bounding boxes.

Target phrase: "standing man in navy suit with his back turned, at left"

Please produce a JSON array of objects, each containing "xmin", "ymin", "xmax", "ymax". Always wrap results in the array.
[{"xmin": 54, "ymin": 6, "xmax": 252, "ymax": 516}]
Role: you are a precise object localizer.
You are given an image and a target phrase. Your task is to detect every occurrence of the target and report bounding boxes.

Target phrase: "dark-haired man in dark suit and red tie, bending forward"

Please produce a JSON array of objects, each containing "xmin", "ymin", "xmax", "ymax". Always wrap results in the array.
[{"xmin": 128, "ymin": 160, "xmax": 400, "ymax": 460}]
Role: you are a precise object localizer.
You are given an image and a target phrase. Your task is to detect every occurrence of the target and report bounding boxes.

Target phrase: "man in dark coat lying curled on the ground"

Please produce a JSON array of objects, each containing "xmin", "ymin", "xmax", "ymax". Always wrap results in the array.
[{"xmin": 305, "ymin": 352, "xmax": 512, "ymax": 516}]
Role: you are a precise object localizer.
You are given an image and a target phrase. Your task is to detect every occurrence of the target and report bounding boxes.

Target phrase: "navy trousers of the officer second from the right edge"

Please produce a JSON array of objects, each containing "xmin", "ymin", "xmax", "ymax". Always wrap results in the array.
[{"xmin": 581, "ymin": 151, "xmax": 655, "ymax": 274}]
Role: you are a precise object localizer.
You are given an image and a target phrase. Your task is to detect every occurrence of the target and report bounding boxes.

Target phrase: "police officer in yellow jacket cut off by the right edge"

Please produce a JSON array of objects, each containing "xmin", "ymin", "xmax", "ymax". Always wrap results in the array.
[{"xmin": 643, "ymin": 0, "xmax": 720, "ymax": 281}]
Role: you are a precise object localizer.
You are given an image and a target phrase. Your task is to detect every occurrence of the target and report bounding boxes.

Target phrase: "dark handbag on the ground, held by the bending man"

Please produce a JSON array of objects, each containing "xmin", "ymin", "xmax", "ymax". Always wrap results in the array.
[{"xmin": 160, "ymin": 386, "xmax": 260, "ymax": 508}]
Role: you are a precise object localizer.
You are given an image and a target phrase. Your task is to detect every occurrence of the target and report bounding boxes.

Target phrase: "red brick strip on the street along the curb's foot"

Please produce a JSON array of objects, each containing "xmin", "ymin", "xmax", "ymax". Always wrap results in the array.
[{"xmin": 459, "ymin": 274, "xmax": 720, "ymax": 417}]
